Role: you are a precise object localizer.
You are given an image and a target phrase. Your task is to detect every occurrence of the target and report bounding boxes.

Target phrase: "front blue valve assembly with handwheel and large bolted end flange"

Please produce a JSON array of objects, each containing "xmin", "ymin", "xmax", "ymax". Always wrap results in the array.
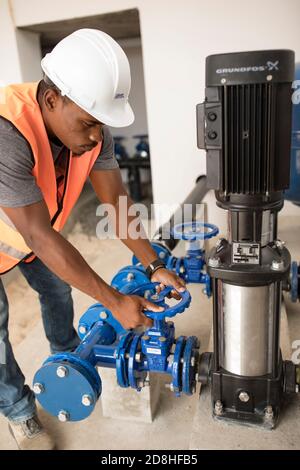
[{"xmin": 33, "ymin": 282, "xmax": 199, "ymax": 421}]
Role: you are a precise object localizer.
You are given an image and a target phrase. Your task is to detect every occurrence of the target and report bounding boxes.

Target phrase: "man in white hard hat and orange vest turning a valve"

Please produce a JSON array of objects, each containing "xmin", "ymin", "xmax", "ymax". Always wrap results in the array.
[{"xmin": 0, "ymin": 29, "xmax": 184, "ymax": 449}]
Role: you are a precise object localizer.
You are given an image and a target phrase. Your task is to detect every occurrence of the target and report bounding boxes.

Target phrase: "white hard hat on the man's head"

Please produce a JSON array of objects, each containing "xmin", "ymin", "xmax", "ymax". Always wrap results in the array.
[{"xmin": 41, "ymin": 29, "xmax": 134, "ymax": 127}]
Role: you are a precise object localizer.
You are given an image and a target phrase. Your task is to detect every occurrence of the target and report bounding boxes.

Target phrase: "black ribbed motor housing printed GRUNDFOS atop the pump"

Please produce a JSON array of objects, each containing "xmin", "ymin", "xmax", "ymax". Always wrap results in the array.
[{"xmin": 198, "ymin": 50, "xmax": 294, "ymax": 194}]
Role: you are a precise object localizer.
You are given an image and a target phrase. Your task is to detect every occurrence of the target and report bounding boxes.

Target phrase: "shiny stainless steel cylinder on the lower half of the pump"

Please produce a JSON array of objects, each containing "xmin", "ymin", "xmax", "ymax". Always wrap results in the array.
[{"xmin": 219, "ymin": 281, "xmax": 278, "ymax": 377}]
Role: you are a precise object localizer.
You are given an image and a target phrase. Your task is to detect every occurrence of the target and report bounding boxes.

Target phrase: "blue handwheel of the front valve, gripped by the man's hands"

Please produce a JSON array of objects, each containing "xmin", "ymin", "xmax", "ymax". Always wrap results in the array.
[{"xmin": 130, "ymin": 282, "xmax": 192, "ymax": 320}]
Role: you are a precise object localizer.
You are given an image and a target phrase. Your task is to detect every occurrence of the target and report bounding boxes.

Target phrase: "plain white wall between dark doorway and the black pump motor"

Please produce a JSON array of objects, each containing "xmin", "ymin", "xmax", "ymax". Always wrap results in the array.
[{"xmin": 5, "ymin": 0, "xmax": 300, "ymax": 224}]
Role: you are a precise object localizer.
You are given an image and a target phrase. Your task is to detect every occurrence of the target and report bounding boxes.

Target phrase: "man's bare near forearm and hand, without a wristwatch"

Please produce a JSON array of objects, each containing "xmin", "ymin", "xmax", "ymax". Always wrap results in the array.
[{"xmin": 2, "ymin": 201, "xmax": 161, "ymax": 328}]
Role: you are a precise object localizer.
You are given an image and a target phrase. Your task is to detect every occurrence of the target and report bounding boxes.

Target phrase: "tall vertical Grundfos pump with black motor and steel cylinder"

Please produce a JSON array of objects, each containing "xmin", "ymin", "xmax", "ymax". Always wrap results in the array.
[{"xmin": 197, "ymin": 50, "xmax": 297, "ymax": 428}]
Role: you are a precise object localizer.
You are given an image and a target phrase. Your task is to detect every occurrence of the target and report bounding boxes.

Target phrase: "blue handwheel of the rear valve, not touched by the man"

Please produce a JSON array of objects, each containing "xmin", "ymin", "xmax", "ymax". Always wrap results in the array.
[{"xmin": 172, "ymin": 222, "xmax": 219, "ymax": 241}]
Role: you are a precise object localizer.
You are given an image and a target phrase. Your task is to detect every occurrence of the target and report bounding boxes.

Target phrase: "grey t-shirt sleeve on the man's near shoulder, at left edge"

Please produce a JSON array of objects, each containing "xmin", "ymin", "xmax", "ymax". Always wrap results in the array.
[{"xmin": 0, "ymin": 117, "xmax": 43, "ymax": 207}]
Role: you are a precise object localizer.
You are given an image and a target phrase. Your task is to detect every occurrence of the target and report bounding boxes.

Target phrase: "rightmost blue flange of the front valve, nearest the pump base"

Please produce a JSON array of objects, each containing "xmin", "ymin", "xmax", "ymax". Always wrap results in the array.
[{"xmin": 182, "ymin": 336, "xmax": 200, "ymax": 395}]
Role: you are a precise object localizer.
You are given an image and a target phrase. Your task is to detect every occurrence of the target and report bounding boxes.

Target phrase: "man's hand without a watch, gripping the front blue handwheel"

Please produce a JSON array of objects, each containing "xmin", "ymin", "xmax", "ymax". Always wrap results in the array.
[{"xmin": 111, "ymin": 294, "xmax": 164, "ymax": 330}]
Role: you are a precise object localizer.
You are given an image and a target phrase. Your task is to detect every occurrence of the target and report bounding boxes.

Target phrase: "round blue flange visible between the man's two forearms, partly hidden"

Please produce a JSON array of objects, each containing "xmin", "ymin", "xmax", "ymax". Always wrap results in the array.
[{"xmin": 111, "ymin": 266, "xmax": 149, "ymax": 294}]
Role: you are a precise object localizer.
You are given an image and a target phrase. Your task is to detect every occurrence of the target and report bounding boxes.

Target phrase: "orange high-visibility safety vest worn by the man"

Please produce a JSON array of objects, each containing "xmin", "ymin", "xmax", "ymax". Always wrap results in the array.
[{"xmin": 0, "ymin": 83, "xmax": 102, "ymax": 274}]
